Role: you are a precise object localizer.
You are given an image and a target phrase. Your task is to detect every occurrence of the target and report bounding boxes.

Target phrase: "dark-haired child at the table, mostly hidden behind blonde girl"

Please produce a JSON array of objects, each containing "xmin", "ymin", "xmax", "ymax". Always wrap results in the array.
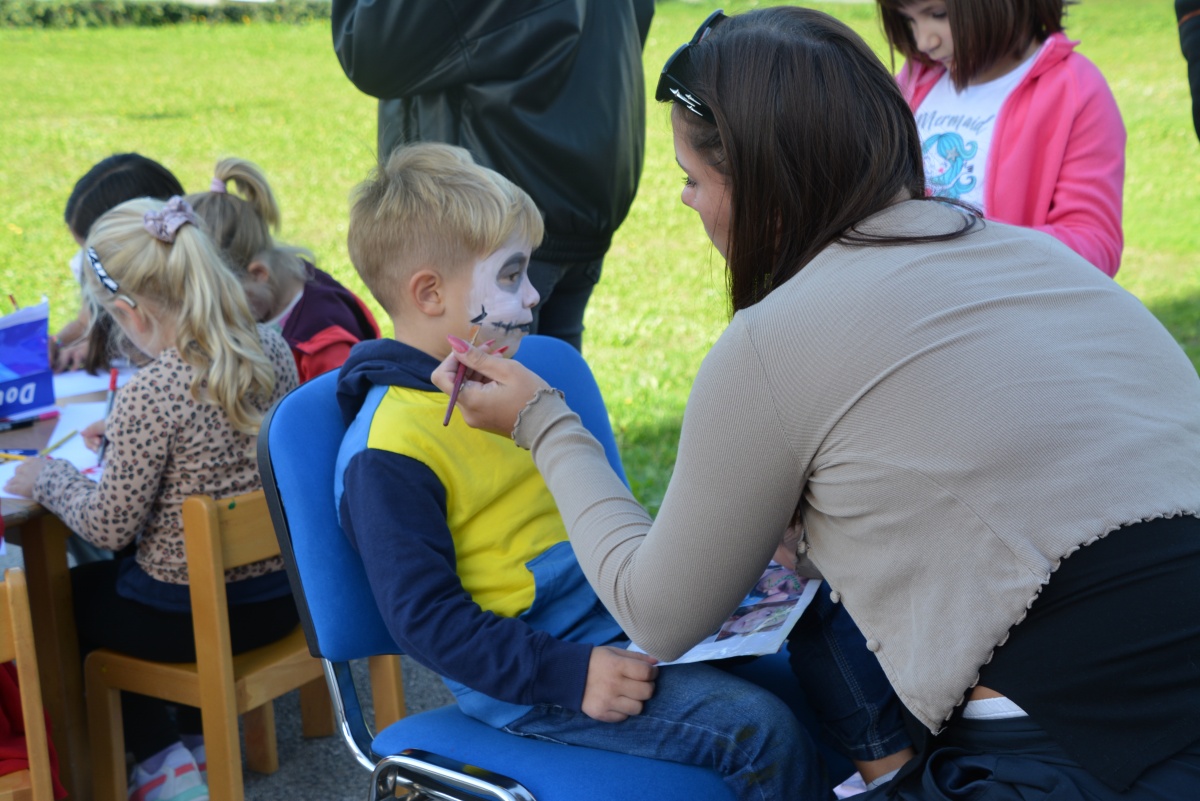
[{"xmin": 50, "ymin": 153, "xmax": 184, "ymax": 373}]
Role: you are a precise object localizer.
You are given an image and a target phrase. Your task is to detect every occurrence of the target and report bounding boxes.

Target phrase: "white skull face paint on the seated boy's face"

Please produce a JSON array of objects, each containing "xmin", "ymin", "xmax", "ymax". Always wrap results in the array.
[{"xmin": 467, "ymin": 240, "xmax": 541, "ymax": 356}]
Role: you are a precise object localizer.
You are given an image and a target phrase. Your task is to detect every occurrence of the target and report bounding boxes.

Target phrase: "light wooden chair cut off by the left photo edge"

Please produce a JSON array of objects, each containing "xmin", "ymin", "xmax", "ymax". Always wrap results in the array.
[{"xmin": 0, "ymin": 567, "xmax": 54, "ymax": 801}]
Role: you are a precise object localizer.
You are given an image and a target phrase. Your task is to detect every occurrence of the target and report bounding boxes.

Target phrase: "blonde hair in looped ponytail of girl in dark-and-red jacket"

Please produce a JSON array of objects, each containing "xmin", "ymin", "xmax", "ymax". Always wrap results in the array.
[{"xmin": 187, "ymin": 158, "xmax": 314, "ymax": 284}]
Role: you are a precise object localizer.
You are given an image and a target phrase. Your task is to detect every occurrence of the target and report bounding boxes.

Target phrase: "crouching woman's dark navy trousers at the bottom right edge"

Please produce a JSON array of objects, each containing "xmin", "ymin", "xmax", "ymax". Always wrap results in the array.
[{"xmin": 856, "ymin": 714, "xmax": 1200, "ymax": 801}]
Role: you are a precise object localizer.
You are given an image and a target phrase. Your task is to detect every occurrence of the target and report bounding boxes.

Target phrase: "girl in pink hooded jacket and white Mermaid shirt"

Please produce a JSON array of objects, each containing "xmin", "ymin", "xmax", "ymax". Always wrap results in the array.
[{"xmin": 876, "ymin": 0, "xmax": 1126, "ymax": 276}]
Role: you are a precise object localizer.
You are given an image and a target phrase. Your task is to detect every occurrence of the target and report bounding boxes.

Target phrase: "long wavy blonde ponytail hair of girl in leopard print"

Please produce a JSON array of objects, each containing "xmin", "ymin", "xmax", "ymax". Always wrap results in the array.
[{"xmin": 83, "ymin": 198, "xmax": 275, "ymax": 434}]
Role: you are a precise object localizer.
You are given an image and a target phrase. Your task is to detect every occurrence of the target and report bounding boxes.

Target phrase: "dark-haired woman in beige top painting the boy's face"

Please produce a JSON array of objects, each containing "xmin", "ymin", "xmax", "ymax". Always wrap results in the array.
[{"xmin": 433, "ymin": 7, "xmax": 1200, "ymax": 801}]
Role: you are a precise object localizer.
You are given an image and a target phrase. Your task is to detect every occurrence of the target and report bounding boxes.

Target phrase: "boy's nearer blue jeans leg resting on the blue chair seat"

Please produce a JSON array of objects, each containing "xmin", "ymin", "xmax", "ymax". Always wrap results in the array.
[{"xmin": 504, "ymin": 663, "xmax": 833, "ymax": 801}]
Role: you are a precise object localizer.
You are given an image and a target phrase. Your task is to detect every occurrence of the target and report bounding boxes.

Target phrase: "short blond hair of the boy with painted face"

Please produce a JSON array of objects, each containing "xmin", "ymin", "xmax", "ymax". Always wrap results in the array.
[{"xmin": 347, "ymin": 143, "xmax": 545, "ymax": 314}]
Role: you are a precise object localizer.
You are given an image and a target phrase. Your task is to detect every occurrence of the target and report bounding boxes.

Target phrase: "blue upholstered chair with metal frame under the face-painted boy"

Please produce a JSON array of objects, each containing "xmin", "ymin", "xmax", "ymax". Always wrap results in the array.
[{"xmin": 258, "ymin": 336, "xmax": 848, "ymax": 801}]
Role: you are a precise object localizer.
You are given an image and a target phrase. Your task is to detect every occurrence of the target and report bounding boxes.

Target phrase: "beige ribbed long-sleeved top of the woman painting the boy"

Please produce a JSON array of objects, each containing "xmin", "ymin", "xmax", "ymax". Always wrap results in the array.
[{"xmin": 514, "ymin": 201, "xmax": 1200, "ymax": 730}]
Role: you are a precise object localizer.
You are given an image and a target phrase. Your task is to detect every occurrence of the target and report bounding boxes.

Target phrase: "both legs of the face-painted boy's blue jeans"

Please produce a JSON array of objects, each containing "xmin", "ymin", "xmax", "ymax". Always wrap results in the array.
[{"xmin": 505, "ymin": 585, "xmax": 912, "ymax": 799}]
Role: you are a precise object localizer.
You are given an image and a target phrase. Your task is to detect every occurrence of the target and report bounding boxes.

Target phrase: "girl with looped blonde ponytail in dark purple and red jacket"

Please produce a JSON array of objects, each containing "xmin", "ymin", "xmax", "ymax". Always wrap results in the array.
[{"xmin": 187, "ymin": 158, "xmax": 379, "ymax": 381}]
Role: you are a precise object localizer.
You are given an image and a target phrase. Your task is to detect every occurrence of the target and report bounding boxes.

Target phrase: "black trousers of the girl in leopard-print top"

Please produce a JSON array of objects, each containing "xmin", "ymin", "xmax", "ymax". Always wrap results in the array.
[{"xmin": 71, "ymin": 559, "xmax": 299, "ymax": 761}]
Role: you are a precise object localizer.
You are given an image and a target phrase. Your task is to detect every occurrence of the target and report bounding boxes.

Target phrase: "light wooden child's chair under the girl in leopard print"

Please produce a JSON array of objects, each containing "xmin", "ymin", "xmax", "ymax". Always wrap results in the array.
[{"xmin": 84, "ymin": 490, "xmax": 334, "ymax": 801}]
